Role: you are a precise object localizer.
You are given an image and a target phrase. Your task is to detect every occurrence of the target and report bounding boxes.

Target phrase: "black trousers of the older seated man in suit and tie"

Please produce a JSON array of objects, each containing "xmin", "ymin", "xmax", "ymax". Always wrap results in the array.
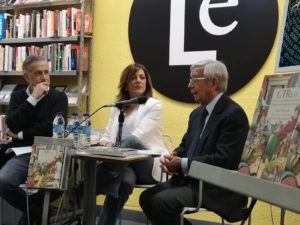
[{"xmin": 140, "ymin": 177, "xmax": 198, "ymax": 225}]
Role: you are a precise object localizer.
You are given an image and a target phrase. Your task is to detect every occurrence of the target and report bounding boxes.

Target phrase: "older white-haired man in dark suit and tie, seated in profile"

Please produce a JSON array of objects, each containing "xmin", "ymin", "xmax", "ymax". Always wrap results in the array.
[{"xmin": 140, "ymin": 60, "xmax": 249, "ymax": 225}]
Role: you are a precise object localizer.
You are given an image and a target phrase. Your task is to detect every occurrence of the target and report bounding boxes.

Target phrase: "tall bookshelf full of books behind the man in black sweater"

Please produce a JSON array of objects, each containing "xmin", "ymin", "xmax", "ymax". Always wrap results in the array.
[{"xmin": 0, "ymin": 0, "xmax": 94, "ymax": 115}]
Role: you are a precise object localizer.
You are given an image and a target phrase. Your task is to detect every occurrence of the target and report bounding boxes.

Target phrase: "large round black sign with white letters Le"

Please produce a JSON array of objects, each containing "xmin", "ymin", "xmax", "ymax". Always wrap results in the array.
[{"xmin": 129, "ymin": 0, "xmax": 278, "ymax": 102}]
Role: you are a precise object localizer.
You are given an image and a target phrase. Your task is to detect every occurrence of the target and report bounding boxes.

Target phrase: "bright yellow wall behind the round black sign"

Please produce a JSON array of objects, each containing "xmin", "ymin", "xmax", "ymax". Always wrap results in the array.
[{"xmin": 90, "ymin": 0, "xmax": 300, "ymax": 225}]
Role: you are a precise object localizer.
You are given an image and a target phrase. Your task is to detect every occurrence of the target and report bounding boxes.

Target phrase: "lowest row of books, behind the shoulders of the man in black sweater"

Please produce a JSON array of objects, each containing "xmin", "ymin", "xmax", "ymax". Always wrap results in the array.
[{"xmin": 0, "ymin": 84, "xmax": 85, "ymax": 105}]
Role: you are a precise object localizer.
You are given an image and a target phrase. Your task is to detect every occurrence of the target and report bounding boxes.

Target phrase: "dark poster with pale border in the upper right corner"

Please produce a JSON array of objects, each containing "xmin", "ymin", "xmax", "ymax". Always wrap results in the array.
[{"xmin": 275, "ymin": 0, "xmax": 300, "ymax": 72}]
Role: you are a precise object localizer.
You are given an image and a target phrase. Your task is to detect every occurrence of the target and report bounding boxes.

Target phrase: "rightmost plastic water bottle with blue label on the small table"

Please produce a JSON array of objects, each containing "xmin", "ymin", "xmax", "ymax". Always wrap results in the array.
[{"xmin": 79, "ymin": 113, "xmax": 91, "ymax": 149}]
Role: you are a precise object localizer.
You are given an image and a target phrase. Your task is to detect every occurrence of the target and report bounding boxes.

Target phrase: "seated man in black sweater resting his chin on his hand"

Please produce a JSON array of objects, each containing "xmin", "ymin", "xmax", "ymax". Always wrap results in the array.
[{"xmin": 0, "ymin": 55, "xmax": 68, "ymax": 225}]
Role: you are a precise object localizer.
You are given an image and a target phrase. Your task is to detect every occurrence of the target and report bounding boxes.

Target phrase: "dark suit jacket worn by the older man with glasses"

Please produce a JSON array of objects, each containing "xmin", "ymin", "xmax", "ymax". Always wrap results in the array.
[{"xmin": 175, "ymin": 94, "xmax": 249, "ymax": 222}]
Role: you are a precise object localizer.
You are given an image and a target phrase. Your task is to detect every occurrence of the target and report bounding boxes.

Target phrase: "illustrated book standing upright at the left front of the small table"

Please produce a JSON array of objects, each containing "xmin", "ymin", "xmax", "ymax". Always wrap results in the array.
[{"xmin": 26, "ymin": 137, "xmax": 73, "ymax": 190}]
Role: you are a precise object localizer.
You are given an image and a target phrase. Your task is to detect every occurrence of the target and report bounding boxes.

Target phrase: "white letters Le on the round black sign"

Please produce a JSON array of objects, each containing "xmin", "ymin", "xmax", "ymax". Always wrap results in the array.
[{"xmin": 169, "ymin": 0, "xmax": 238, "ymax": 66}]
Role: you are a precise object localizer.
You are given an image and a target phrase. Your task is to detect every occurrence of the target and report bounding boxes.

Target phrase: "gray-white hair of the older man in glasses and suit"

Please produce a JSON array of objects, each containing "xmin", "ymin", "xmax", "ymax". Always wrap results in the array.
[{"xmin": 190, "ymin": 60, "xmax": 229, "ymax": 92}]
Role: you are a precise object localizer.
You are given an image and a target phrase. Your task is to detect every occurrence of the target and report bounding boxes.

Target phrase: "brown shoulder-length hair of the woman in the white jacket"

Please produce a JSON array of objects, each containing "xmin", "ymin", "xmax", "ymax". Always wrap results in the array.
[{"xmin": 117, "ymin": 63, "xmax": 153, "ymax": 101}]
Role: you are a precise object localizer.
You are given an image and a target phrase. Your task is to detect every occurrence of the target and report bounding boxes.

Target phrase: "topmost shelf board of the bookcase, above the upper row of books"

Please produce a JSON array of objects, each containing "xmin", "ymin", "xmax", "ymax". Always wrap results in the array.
[{"xmin": 0, "ymin": 0, "xmax": 82, "ymax": 11}]
